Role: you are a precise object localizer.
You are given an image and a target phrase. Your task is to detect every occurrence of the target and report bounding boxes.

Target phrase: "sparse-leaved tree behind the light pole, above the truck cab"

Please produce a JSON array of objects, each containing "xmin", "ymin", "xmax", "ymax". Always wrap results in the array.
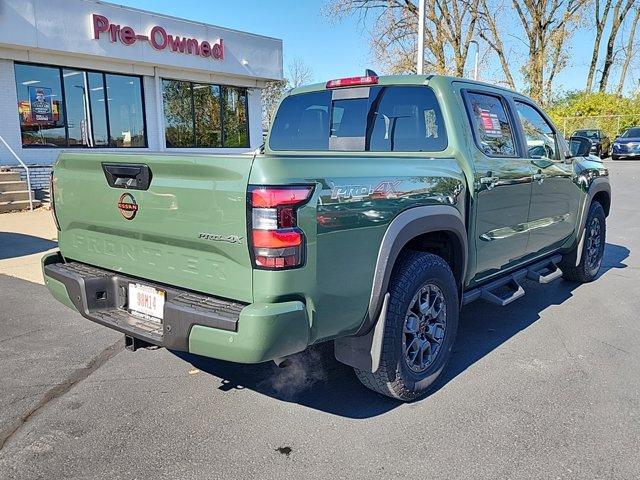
[{"xmin": 326, "ymin": 0, "xmax": 480, "ymax": 77}]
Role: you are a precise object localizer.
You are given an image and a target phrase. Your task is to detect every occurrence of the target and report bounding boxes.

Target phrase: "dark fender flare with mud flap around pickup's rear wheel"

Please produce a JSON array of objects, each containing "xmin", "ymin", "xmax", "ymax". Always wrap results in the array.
[{"xmin": 334, "ymin": 205, "xmax": 468, "ymax": 372}]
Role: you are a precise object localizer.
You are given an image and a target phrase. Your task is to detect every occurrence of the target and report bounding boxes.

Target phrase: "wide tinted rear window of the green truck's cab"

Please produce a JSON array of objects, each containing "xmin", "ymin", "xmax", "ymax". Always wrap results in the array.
[{"xmin": 269, "ymin": 86, "xmax": 447, "ymax": 152}]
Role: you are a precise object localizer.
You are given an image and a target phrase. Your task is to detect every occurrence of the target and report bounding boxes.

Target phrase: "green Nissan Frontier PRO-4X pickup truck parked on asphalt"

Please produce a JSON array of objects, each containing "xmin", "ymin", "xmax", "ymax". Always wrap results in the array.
[{"xmin": 43, "ymin": 71, "xmax": 611, "ymax": 401}]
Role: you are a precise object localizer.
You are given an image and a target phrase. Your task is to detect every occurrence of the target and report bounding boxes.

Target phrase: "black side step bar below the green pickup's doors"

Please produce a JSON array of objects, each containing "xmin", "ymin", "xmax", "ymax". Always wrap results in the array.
[{"xmin": 462, "ymin": 255, "xmax": 562, "ymax": 307}]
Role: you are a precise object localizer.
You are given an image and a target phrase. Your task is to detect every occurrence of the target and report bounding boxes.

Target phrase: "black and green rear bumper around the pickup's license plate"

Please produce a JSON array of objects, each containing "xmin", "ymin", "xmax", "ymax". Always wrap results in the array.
[{"xmin": 42, "ymin": 253, "xmax": 309, "ymax": 363}]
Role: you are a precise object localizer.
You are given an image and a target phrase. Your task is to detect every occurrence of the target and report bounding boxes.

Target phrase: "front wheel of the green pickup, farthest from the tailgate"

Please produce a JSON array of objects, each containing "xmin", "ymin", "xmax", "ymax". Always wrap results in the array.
[{"xmin": 560, "ymin": 202, "xmax": 607, "ymax": 283}]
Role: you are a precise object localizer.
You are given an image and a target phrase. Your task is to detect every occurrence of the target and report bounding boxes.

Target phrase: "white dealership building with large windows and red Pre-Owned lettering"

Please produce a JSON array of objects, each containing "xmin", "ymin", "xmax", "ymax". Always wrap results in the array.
[{"xmin": 0, "ymin": 0, "xmax": 282, "ymax": 195}]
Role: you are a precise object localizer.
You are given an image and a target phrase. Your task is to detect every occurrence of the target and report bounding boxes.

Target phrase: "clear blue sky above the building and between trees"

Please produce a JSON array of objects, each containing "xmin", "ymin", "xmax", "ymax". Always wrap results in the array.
[{"xmin": 113, "ymin": 0, "xmax": 640, "ymax": 95}]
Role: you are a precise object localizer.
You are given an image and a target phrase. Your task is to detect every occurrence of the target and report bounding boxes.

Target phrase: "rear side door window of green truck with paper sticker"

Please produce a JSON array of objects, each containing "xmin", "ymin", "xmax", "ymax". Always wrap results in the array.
[{"xmin": 467, "ymin": 92, "xmax": 516, "ymax": 157}]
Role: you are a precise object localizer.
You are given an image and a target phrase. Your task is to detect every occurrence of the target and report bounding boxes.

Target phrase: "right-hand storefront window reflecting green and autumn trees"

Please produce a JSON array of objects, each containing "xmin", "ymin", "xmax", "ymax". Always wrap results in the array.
[{"xmin": 162, "ymin": 80, "xmax": 249, "ymax": 148}]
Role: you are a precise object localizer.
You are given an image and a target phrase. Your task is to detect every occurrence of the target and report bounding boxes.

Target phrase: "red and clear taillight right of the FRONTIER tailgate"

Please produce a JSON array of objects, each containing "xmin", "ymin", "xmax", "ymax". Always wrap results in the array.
[{"xmin": 249, "ymin": 185, "xmax": 313, "ymax": 270}]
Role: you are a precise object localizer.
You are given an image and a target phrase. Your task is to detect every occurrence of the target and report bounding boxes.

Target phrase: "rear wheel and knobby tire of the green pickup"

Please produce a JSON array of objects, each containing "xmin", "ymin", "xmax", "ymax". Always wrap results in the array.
[{"xmin": 354, "ymin": 252, "xmax": 460, "ymax": 402}]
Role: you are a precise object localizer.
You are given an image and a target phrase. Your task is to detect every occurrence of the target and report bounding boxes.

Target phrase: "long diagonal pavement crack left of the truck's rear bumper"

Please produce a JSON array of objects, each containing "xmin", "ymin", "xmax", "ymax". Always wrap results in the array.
[{"xmin": 0, "ymin": 339, "xmax": 124, "ymax": 450}]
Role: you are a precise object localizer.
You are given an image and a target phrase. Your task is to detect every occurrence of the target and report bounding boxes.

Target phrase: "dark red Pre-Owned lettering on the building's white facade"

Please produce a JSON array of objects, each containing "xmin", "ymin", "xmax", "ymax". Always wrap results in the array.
[{"xmin": 92, "ymin": 13, "xmax": 224, "ymax": 60}]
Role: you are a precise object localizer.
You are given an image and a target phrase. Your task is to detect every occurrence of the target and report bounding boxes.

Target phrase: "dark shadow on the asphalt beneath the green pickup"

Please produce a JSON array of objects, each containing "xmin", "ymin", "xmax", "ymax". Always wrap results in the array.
[{"xmin": 173, "ymin": 244, "xmax": 629, "ymax": 419}]
